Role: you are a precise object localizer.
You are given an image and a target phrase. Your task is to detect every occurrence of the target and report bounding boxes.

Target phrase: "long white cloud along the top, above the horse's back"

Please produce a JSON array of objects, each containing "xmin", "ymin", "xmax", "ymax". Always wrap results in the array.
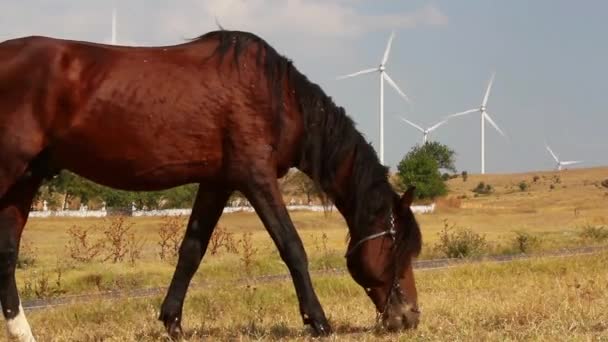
[{"xmin": 0, "ymin": 0, "xmax": 448, "ymax": 45}]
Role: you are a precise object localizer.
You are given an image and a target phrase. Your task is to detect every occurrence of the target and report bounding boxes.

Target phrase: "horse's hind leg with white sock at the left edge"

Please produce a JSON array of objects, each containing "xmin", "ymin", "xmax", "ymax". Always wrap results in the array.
[{"xmin": 0, "ymin": 177, "xmax": 41, "ymax": 342}]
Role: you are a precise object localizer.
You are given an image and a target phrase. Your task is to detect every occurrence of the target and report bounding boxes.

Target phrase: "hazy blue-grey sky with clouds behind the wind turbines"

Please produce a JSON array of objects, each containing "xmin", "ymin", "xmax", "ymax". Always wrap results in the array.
[{"xmin": 0, "ymin": 0, "xmax": 608, "ymax": 173}]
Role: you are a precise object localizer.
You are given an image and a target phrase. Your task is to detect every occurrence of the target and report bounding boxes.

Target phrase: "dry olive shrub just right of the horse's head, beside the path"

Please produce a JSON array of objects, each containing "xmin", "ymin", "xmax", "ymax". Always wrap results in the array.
[{"xmin": 435, "ymin": 220, "xmax": 487, "ymax": 258}]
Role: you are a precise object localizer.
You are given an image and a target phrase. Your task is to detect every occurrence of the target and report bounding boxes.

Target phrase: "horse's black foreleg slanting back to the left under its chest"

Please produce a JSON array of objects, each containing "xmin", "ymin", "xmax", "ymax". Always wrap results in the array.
[{"xmin": 159, "ymin": 189, "xmax": 231, "ymax": 337}]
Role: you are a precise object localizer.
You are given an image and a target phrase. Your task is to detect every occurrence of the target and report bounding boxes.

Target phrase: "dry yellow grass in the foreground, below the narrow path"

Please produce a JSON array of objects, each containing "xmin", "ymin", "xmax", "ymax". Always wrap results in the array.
[{"xmin": 29, "ymin": 253, "xmax": 608, "ymax": 341}]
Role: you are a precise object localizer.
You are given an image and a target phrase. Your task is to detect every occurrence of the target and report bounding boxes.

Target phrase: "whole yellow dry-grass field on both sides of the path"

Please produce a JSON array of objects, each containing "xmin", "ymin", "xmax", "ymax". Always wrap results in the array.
[{"xmin": 11, "ymin": 168, "xmax": 608, "ymax": 341}]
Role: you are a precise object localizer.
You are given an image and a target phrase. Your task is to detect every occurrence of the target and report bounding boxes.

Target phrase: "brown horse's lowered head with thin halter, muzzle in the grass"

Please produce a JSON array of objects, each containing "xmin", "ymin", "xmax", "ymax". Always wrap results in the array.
[{"xmin": 346, "ymin": 187, "xmax": 421, "ymax": 330}]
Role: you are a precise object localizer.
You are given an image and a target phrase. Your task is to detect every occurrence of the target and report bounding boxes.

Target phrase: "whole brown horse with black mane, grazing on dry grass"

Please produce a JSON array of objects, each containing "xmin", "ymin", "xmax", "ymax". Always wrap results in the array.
[{"xmin": 0, "ymin": 30, "xmax": 421, "ymax": 341}]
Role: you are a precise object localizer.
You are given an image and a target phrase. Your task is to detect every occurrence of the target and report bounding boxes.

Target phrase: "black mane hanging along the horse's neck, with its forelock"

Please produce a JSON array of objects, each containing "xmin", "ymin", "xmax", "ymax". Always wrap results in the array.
[{"xmin": 195, "ymin": 29, "xmax": 420, "ymax": 255}]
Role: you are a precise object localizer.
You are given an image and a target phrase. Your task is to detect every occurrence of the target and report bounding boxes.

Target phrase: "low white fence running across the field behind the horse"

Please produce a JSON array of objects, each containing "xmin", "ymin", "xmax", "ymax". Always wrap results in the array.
[{"xmin": 30, "ymin": 203, "xmax": 435, "ymax": 218}]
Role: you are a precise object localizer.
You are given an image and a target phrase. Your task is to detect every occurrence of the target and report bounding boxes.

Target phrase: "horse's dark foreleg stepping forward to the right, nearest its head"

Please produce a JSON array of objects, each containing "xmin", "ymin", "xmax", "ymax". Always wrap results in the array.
[{"xmin": 241, "ymin": 175, "xmax": 331, "ymax": 335}]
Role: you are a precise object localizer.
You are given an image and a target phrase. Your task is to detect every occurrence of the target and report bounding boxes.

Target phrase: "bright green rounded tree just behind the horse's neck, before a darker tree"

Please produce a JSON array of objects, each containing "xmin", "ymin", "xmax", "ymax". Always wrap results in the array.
[{"xmin": 397, "ymin": 147, "xmax": 447, "ymax": 199}]
